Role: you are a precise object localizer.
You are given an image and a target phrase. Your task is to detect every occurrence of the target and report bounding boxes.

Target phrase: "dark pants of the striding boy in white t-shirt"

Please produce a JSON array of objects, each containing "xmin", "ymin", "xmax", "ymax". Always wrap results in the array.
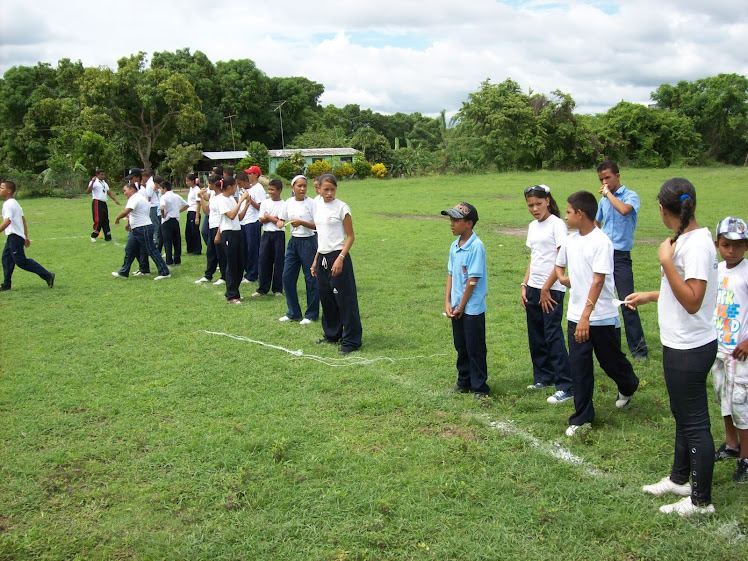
[{"xmin": 567, "ymin": 321, "xmax": 639, "ymax": 425}]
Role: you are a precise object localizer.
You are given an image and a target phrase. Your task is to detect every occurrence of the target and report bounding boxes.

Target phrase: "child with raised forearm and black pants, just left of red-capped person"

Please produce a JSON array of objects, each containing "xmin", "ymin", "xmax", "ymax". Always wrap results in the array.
[{"xmin": 214, "ymin": 178, "xmax": 249, "ymax": 304}]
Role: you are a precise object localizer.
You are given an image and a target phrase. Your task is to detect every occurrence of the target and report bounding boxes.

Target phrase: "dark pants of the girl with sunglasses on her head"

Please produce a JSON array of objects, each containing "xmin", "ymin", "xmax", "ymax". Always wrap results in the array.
[{"xmin": 525, "ymin": 286, "xmax": 571, "ymax": 392}]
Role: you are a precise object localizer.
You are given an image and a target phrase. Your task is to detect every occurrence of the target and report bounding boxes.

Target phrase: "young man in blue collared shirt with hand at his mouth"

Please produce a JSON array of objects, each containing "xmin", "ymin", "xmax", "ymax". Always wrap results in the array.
[{"xmin": 595, "ymin": 160, "xmax": 649, "ymax": 360}]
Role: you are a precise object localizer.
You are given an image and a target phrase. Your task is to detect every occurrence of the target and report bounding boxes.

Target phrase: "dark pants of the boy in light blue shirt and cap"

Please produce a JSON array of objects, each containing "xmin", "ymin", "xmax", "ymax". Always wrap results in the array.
[{"xmin": 452, "ymin": 313, "xmax": 491, "ymax": 393}]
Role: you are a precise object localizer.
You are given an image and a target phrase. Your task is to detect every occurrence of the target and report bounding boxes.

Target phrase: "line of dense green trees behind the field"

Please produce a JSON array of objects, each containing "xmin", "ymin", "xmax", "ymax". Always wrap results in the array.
[{"xmin": 0, "ymin": 45, "xmax": 748, "ymax": 192}]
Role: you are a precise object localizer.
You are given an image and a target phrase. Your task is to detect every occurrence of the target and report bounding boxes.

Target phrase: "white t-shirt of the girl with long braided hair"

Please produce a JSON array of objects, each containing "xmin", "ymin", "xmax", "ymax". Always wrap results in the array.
[{"xmin": 657, "ymin": 228, "xmax": 719, "ymax": 350}]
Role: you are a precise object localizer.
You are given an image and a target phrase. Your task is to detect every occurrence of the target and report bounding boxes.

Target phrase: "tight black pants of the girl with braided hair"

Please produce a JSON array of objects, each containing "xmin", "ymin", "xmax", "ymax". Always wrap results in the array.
[{"xmin": 662, "ymin": 340, "xmax": 717, "ymax": 505}]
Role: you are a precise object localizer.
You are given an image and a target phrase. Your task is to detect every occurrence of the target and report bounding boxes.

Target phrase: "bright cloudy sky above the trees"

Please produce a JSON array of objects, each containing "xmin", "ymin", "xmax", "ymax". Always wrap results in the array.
[{"xmin": 0, "ymin": 0, "xmax": 748, "ymax": 115}]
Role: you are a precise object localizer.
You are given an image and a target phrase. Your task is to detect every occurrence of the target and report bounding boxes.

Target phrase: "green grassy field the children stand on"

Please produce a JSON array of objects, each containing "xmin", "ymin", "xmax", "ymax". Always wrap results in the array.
[{"xmin": 0, "ymin": 168, "xmax": 748, "ymax": 561}]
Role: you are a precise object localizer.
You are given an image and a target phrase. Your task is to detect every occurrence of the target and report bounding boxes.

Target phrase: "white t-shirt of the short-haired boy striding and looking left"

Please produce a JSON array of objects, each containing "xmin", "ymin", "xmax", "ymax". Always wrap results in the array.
[{"xmin": 556, "ymin": 227, "xmax": 618, "ymax": 322}]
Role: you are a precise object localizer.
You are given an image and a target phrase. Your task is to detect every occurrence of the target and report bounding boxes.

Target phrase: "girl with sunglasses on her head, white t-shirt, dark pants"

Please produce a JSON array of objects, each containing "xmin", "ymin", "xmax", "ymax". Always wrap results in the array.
[{"xmin": 520, "ymin": 185, "xmax": 574, "ymax": 403}]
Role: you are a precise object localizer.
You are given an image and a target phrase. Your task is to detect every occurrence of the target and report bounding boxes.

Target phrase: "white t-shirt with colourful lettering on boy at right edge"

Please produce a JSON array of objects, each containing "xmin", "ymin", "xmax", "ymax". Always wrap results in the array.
[{"xmin": 714, "ymin": 259, "xmax": 748, "ymax": 353}]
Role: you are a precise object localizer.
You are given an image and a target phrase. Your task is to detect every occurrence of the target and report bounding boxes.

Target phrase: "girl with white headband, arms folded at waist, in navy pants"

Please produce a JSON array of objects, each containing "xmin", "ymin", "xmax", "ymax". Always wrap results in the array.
[{"xmin": 279, "ymin": 175, "xmax": 319, "ymax": 325}]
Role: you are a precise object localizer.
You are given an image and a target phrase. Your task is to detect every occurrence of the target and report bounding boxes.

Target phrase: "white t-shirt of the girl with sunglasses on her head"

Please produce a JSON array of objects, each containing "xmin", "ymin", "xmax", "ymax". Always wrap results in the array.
[{"xmin": 525, "ymin": 214, "xmax": 569, "ymax": 292}]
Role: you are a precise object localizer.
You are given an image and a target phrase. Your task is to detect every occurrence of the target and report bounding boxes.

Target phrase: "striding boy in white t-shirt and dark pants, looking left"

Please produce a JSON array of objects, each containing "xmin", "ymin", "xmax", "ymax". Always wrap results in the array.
[{"xmin": 556, "ymin": 191, "xmax": 639, "ymax": 436}]
